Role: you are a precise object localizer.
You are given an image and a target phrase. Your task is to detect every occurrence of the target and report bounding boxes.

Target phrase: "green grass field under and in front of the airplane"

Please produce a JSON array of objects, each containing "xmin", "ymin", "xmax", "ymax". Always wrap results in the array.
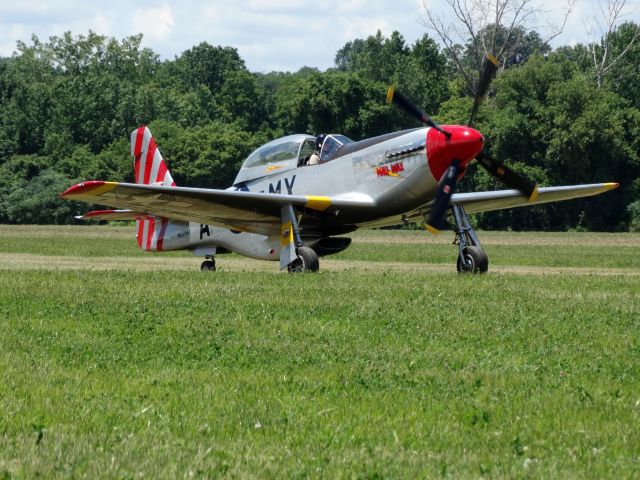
[{"xmin": 0, "ymin": 226, "xmax": 640, "ymax": 479}]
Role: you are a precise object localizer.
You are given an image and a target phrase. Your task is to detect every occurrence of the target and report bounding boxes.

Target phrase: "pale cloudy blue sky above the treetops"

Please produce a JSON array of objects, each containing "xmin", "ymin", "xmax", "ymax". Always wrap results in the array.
[{"xmin": 0, "ymin": 0, "xmax": 640, "ymax": 72}]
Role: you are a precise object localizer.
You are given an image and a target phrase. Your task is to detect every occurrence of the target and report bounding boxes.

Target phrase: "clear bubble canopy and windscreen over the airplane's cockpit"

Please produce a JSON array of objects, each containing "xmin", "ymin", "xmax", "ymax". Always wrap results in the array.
[{"xmin": 233, "ymin": 134, "xmax": 353, "ymax": 185}]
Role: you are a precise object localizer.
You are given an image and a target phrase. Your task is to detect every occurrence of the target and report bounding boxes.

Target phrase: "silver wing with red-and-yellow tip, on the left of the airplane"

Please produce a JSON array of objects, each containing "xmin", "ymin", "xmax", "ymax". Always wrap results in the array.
[{"xmin": 60, "ymin": 181, "xmax": 375, "ymax": 235}]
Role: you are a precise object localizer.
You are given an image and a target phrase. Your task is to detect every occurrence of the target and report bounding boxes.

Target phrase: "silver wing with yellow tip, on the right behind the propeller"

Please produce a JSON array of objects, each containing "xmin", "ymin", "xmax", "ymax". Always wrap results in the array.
[{"xmin": 451, "ymin": 183, "xmax": 618, "ymax": 213}]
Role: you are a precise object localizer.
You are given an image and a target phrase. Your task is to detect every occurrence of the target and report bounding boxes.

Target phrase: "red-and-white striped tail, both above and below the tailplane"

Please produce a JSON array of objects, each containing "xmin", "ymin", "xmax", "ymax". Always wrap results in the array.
[{"xmin": 131, "ymin": 126, "xmax": 176, "ymax": 252}]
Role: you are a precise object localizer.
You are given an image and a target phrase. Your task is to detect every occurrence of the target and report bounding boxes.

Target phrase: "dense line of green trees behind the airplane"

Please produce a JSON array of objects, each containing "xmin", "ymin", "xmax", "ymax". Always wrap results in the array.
[{"xmin": 0, "ymin": 23, "xmax": 640, "ymax": 231}]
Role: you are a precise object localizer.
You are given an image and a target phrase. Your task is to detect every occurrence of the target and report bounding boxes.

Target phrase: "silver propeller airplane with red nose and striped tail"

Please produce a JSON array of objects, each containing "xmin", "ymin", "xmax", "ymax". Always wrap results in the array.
[{"xmin": 61, "ymin": 58, "xmax": 618, "ymax": 273}]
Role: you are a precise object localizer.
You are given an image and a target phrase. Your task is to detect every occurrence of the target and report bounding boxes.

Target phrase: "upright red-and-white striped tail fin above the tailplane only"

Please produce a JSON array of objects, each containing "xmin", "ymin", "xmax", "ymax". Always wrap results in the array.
[{"xmin": 131, "ymin": 126, "xmax": 176, "ymax": 187}]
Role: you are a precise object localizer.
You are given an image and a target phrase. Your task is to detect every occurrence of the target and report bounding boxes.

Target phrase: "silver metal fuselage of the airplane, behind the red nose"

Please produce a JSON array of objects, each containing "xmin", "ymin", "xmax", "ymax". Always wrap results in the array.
[{"xmin": 154, "ymin": 128, "xmax": 438, "ymax": 260}]
